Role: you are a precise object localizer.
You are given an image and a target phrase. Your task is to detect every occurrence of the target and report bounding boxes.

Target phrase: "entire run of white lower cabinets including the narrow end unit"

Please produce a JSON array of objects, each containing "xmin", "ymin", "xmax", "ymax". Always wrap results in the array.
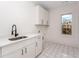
[{"xmin": 2, "ymin": 35, "xmax": 42, "ymax": 58}]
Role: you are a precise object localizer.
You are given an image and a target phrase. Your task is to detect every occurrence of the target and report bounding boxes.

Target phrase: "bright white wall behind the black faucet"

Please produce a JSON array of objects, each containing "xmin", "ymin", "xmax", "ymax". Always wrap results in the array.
[{"xmin": 0, "ymin": 1, "xmax": 37, "ymax": 37}]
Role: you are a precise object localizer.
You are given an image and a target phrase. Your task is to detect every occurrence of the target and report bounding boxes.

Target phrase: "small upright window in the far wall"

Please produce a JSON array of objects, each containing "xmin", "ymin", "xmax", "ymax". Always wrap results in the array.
[{"xmin": 62, "ymin": 14, "xmax": 72, "ymax": 35}]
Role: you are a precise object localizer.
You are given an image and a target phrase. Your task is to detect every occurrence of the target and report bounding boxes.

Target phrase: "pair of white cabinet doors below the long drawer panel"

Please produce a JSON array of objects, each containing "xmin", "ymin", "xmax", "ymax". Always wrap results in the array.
[{"xmin": 3, "ymin": 43, "xmax": 35, "ymax": 58}]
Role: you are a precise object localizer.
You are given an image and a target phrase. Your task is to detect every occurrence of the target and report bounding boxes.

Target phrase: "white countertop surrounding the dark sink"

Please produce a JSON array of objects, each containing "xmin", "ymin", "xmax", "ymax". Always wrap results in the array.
[{"xmin": 0, "ymin": 34, "xmax": 40, "ymax": 47}]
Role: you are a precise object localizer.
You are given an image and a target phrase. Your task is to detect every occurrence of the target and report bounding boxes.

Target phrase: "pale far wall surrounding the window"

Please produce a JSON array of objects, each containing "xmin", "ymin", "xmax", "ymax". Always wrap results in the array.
[{"xmin": 46, "ymin": 5, "xmax": 79, "ymax": 47}]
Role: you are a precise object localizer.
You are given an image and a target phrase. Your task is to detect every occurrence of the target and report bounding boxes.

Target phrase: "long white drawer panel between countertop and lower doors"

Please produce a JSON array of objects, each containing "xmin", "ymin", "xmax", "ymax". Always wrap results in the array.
[{"xmin": 2, "ymin": 38, "xmax": 35, "ymax": 56}]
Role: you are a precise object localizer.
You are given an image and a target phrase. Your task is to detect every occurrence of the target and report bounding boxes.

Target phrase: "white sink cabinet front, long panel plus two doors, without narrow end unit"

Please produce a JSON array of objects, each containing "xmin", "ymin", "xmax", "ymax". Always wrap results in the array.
[{"xmin": 2, "ymin": 36, "xmax": 37, "ymax": 58}]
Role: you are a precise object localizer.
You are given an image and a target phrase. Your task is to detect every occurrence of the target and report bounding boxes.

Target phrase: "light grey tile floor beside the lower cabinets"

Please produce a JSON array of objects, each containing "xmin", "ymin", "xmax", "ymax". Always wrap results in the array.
[{"xmin": 38, "ymin": 43, "xmax": 79, "ymax": 58}]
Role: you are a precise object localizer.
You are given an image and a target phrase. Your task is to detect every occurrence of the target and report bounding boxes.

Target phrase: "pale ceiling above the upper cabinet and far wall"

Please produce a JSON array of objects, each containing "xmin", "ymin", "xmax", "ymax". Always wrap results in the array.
[{"xmin": 34, "ymin": 1, "xmax": 79, "ymax": 9}]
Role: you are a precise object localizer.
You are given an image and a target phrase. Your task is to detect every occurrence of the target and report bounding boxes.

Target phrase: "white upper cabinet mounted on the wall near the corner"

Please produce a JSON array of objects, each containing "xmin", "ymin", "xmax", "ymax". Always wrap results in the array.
[{"xmin": 36, "ymin": 5, "xmax": 48, "ymax": 26}]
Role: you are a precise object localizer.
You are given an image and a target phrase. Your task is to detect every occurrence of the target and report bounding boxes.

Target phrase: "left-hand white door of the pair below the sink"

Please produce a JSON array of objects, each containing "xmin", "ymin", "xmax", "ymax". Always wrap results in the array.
[{"xmin": 2, "ymin": 49, "xmax": 23, "ymax": 58}]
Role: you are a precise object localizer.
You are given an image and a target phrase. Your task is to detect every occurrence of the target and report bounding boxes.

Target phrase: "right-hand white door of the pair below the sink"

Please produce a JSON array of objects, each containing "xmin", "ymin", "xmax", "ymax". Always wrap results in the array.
[{"xmin": 24, "ymin": 42, "xmax": 35, "ymax": 58}]
